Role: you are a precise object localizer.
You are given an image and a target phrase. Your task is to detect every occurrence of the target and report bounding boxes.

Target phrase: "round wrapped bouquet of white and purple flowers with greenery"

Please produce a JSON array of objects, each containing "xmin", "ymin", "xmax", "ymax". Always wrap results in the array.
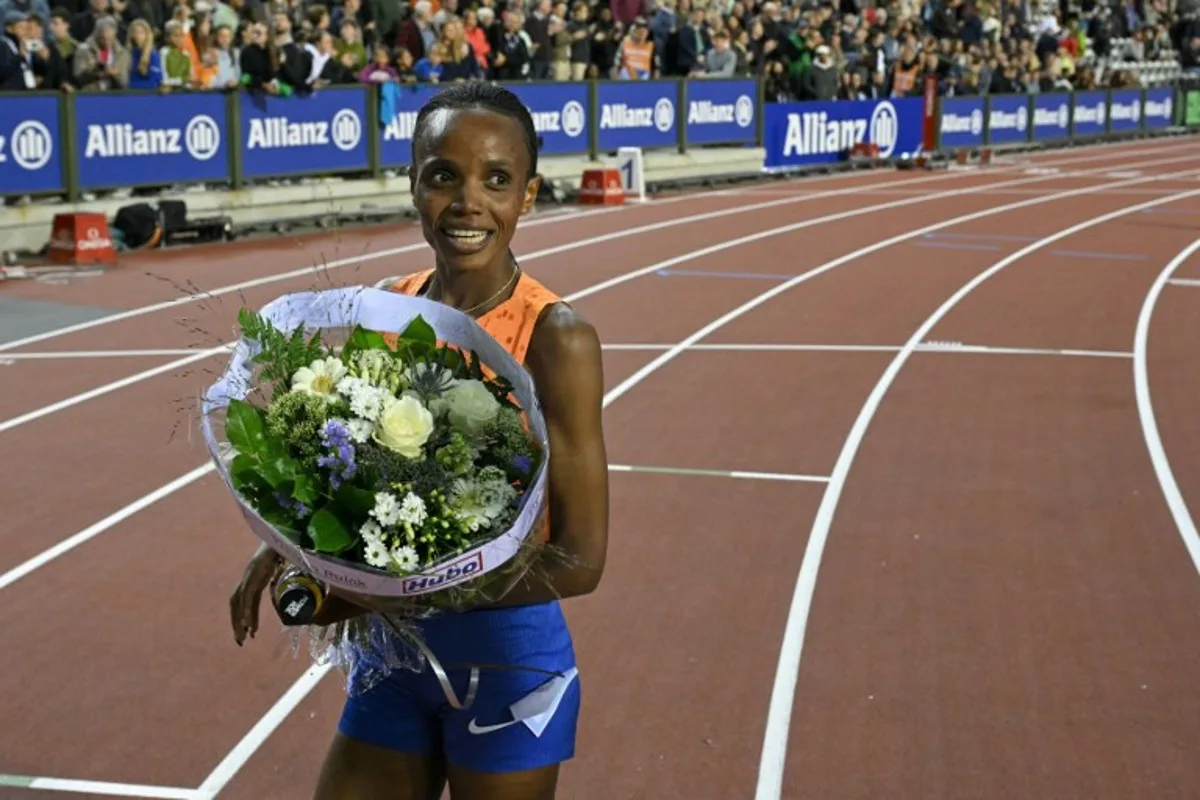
[{"xmin": 200, "ymin": 287, "xmax": 561, "ymax": 693}]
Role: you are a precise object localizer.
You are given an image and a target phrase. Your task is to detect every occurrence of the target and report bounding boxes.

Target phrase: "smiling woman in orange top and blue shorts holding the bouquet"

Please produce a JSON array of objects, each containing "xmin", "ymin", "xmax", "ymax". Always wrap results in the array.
[{"xmin": 230, "ymin": 82, "xmax": 608, "ymax": 800}]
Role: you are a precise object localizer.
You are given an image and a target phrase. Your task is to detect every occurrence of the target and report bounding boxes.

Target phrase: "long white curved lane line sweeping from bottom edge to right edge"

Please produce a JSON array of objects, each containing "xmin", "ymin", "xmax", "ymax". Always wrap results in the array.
[{"xmin": 755, "ymin": 190, "xmax": 1200, "ymax": 800}]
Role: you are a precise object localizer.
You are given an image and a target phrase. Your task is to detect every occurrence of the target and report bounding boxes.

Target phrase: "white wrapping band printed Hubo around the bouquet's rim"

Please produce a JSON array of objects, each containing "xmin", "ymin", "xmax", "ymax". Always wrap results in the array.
[{"xmin": 200, "ymin": 287, "xmax": 550, "ymax": 597}]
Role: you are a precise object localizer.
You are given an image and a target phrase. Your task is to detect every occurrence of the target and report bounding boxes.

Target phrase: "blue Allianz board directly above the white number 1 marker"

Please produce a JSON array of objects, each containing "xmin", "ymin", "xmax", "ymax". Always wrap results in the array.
[{"xmin": 596, "ymin": 80, "xmax": 679, "ymax": 150}]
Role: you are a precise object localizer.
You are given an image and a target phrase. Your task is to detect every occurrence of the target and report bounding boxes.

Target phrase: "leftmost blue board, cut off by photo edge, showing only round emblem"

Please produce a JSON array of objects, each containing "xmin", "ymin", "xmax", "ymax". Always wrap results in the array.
[{"xmin": 0, "ymin": 95, "xmax": 65, "ymax": 194}]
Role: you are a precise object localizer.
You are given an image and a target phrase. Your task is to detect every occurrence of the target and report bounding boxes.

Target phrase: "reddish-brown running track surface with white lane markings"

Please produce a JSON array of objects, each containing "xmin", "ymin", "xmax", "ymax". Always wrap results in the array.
[{"xmin": 0, "ymin": 139, "xmax": 1200, "ymax": 800}]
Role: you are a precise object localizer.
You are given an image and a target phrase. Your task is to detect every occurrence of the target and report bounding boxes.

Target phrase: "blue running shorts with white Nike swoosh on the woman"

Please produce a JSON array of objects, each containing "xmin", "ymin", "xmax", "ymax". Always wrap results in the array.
[{"xmin": 338, "ymin": 601, "xmax": 580, "ymax": 772}]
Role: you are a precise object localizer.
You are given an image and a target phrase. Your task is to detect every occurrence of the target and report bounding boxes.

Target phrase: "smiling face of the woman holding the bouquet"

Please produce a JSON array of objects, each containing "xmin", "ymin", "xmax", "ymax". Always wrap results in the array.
[{"xmin": 410, "ymin": 109, "xmax": 541, "ymax": 270}]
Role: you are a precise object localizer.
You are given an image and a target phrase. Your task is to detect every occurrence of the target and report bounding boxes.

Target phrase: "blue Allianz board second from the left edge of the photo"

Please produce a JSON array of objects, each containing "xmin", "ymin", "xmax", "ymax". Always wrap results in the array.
[{"xmin": 76, "ymin": 92, "xmax": 229, "ymax": 190}]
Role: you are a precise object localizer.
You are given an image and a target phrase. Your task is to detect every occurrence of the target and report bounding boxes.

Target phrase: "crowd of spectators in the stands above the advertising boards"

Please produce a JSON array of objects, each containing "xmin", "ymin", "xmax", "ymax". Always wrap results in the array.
[{"xmin": 0, "ymin": 0, "xmax": 1200, "ymax": 101}]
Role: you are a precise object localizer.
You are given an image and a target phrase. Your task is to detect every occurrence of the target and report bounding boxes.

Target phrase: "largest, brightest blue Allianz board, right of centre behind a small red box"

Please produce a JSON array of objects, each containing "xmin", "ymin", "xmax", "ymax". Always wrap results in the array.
[{"xmin": 763, "ymin": 97, "xmax": 924, "ymax": 169}]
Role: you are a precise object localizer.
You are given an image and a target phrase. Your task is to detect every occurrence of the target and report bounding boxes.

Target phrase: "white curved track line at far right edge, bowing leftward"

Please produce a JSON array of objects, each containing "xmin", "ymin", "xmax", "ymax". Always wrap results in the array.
[{"xmin": 1133, "ymin": 239, "xmax": 1200, "ymax": 572}]
